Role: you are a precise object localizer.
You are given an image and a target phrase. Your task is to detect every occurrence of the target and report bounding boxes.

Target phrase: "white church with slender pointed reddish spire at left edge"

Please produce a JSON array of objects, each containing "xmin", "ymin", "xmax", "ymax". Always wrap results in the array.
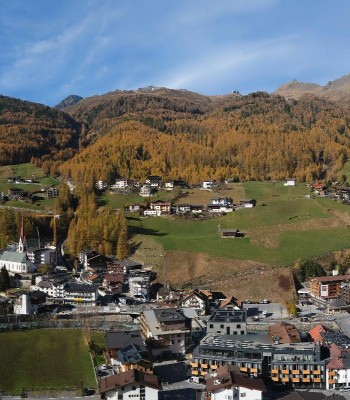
[{"xmin": 0, "ymin": 218, "xmax": 36, "ymax": 274}]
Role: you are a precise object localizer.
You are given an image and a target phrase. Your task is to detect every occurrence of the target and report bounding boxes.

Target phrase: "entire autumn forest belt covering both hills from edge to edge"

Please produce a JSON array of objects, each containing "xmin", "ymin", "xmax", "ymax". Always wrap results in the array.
[{"xmin": 0, "ymin": 88, "xmax": 350, "ymax": 183}]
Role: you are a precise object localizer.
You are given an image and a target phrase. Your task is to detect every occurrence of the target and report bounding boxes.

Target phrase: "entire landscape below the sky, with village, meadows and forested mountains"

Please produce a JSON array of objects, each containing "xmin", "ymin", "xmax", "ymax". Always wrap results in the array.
[{"xmin": 5, "ymin": 75, "xmax": 350, "ymax": 400}]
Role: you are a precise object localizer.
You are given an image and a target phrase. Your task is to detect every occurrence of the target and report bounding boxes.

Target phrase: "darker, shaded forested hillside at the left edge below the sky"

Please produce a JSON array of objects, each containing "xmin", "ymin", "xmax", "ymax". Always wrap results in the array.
[{"xmin": 0, "ymin": 96, "xmax": 81, "ymax": 166}]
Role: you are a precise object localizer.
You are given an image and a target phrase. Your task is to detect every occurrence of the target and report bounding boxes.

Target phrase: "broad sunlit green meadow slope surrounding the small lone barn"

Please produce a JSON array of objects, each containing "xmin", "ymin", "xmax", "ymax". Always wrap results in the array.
[{"xmin": 129, "ymin": 182, "xmax": 350, "ymax": 266}]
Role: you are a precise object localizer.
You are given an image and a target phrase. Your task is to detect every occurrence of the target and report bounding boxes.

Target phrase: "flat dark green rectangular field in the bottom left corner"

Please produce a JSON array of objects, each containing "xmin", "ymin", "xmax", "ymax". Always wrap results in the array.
[{"xmin": 0, "ymin": 329, "xmax": 96, "ymax": 394}]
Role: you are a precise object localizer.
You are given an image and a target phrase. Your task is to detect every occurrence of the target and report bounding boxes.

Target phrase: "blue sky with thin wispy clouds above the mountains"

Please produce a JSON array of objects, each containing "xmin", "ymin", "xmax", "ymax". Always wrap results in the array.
[{"xmin": 0, "ymin": 0, "xmax": 350, "ymax": 105}]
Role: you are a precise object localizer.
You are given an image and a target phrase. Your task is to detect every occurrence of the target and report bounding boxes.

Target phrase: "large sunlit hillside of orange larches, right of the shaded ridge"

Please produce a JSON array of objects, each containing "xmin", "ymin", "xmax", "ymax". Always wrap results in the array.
[{"xmin": 60, "ymin": 90, "xmax": 350, "ymax": 183}]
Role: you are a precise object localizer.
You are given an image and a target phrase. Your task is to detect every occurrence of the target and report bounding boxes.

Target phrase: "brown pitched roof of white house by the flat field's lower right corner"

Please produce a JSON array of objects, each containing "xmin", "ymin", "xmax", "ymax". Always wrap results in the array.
[{"xmin": 100, "ymin": 369, "xmax": 160, "ymax": 393}]
